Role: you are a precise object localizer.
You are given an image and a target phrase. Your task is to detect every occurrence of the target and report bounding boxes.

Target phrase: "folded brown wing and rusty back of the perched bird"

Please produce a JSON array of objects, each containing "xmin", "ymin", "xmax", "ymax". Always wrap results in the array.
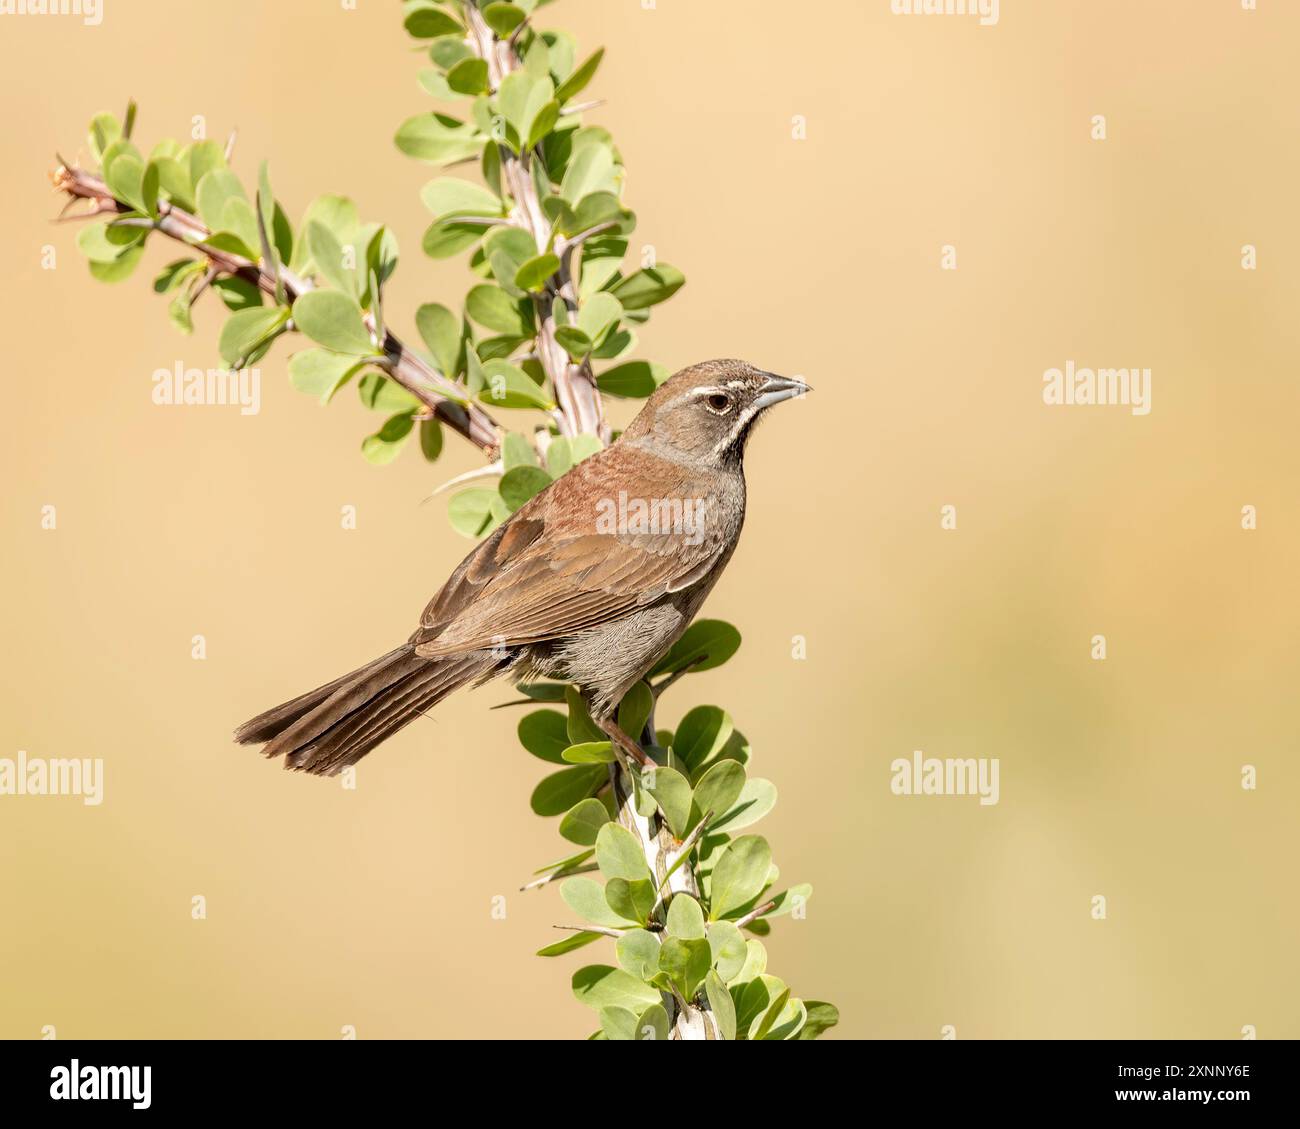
[{"xmin": 411, "ymin": 447, "xmax": 729, "ymax": 658}]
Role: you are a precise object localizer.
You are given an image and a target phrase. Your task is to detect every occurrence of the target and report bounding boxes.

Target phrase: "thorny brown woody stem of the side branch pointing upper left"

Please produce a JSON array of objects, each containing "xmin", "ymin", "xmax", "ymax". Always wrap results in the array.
[{"xmin": 53, "ymin": 165, "xmax": 502, "ymax": 458}]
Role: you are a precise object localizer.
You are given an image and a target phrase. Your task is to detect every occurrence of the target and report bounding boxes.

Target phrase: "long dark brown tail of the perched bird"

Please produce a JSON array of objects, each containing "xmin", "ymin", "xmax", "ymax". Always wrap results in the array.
[{"xmin": 235, "ymin": 644, "xmax": 503, "ymax": 777}]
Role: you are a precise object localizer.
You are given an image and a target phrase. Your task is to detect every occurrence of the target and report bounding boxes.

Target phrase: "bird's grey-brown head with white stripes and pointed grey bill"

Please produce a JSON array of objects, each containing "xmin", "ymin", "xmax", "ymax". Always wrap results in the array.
[{"xmin": 623, "ymin": 360, "xmax": 811, "ymax": 466}]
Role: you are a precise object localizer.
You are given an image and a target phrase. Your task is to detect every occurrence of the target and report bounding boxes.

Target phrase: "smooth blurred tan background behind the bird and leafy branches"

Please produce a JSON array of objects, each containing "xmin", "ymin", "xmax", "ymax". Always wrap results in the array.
[{"xmin": 0, "ymin": 0, "xmax": 1300, "ymax": 1038}]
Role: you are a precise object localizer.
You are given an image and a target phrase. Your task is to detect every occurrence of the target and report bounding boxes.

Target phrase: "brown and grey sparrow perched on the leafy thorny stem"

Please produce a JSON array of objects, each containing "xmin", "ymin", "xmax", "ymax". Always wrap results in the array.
[{"xmin": 235, "ymin": 359, "xmax": 811, "ymax": 777}]
